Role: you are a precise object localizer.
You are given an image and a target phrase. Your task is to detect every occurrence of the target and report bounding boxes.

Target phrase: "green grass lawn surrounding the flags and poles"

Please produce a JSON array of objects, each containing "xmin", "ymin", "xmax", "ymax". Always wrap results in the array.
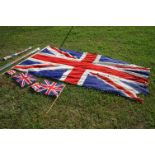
[{"xmin": 0, "ymin": 27, "xmax": 155, "ymax": 128}]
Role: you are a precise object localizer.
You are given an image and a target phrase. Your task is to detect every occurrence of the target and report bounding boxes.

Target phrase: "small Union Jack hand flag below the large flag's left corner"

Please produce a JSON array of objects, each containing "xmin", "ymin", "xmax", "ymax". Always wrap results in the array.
[{"xmin": 13, "ymin": 73, "xmax": 36, "ymax": 88}]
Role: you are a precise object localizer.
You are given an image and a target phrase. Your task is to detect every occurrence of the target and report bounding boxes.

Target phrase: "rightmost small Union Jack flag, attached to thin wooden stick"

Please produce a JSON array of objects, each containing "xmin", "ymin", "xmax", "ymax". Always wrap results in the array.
[{"xmin": 41, "ymin": 80, "xmax": 65, "ymax": 97}]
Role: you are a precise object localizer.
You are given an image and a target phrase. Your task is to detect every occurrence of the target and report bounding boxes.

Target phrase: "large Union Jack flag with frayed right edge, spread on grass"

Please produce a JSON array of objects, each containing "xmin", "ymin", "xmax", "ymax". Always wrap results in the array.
[{"xmin": 14, "ymin": 46, "xmax": 150, "ymax": 102}]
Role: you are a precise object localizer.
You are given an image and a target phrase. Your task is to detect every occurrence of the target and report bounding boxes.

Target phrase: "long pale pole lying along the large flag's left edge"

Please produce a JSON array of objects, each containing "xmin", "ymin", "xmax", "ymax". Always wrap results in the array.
[{"xmin": 0, "ymin": 48, "xmax": 40, "ymax": 74}]
